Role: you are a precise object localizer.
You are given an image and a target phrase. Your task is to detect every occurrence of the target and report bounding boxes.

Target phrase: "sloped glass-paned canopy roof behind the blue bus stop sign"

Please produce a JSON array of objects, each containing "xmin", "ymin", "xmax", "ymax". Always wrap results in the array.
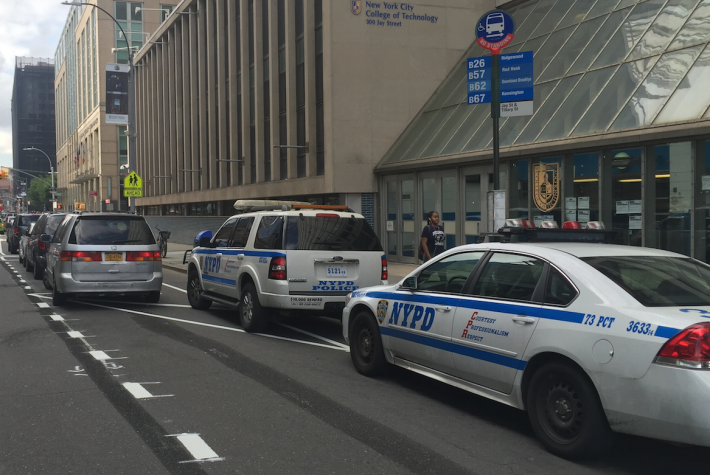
[{"xmin": 381, "ymin": 0, "xmax": 710, "ymax": 164}]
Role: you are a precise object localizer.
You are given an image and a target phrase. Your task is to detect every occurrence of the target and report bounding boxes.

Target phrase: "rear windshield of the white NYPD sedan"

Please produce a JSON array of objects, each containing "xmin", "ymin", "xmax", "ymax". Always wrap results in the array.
[{"xmin": 582, "ymin": 256, "xmax": 710, "ymax": 307}]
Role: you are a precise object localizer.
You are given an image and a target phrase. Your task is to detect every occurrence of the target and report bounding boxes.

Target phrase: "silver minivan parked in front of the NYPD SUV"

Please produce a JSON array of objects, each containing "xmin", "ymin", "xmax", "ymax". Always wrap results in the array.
[{"xmin": 46, "ymin": 213, "xmax": 163, "ymax": 306}]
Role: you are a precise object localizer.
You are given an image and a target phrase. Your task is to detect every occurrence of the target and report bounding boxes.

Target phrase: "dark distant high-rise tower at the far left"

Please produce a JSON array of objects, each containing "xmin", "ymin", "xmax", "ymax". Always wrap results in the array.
[{"xmin": 12, "ymin": 57, "xmax": 56, "ymax": 201}]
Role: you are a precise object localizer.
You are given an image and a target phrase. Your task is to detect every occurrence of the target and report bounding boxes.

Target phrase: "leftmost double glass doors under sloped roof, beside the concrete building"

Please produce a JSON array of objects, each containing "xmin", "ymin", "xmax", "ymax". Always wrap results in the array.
[{"xmin": 385, "ymin": 175, "xmax": 419, "ymax": 264}]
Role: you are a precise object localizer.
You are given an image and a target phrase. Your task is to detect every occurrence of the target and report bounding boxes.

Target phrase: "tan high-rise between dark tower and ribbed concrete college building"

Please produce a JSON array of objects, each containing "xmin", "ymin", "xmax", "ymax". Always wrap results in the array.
[{"xmin": 54, "ymin": 0, "xmax": 176, "ymax": 211}]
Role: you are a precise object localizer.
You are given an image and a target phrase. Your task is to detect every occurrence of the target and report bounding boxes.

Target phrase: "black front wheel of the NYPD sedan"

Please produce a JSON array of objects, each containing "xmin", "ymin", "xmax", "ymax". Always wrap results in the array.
[{"xmin": 350, "ymin": 311, "xmax": 387, "ymax": 376}]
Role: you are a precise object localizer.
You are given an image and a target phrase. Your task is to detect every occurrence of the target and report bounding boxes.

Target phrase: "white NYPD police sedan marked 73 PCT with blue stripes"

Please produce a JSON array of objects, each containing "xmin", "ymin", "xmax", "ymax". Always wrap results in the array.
[{"xmin": 343, "ymin": 242, "xmax": 710, "ymax": 458}]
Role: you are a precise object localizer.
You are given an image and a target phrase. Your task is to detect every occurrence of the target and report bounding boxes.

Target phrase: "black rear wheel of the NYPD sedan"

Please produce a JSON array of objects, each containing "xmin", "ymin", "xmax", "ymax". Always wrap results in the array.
[{"xmin": 527, "ymin": 362, "xmax": 613, "ymax": 459}]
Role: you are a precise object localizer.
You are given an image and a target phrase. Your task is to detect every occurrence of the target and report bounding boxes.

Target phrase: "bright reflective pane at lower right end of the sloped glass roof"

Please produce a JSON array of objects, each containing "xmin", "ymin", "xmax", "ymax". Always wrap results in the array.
[{"xmin": 653, "ymin": 47, "xmax": 710, "ymax": 124}]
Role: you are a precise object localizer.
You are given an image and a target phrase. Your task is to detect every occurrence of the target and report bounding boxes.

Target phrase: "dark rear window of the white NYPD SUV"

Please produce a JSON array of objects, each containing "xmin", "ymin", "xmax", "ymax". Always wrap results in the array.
[{"xmin": 285, "ymin": 216, "xmax": 382, "ymax": 252}]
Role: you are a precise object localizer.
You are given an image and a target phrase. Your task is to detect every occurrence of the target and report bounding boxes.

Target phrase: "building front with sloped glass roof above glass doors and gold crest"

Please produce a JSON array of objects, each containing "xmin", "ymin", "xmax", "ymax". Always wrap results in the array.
[{"xmin": 382, "ymin": 0, "xmax": 710, "ymax": 262}]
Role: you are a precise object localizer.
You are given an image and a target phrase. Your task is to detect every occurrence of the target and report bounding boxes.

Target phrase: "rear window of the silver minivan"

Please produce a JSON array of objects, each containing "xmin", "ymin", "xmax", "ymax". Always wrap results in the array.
[{"xmin": 69, "ymin": 216, "xmax": 155, "ymax": 245}]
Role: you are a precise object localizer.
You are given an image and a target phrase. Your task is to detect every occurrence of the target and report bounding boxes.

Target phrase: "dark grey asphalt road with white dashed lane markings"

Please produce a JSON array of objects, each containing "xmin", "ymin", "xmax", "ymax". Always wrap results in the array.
[{"xmin": 0, "ymin": 238, "xmax": 710, "ymax": 475}]
